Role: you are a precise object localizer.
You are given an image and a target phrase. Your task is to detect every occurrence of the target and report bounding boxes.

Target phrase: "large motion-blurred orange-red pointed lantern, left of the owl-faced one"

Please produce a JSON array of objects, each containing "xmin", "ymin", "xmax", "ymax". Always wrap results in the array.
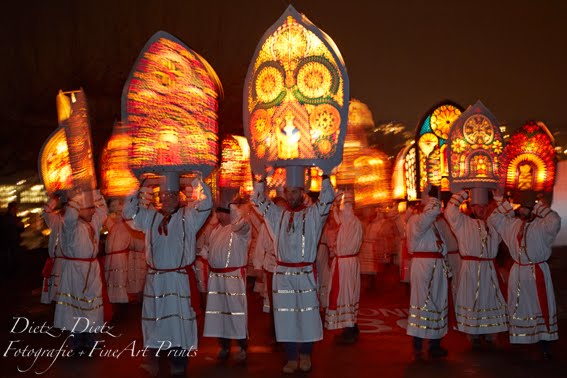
[{"xmin": 122, "ymin": 31, "xmax": 222, "ymax": 191}]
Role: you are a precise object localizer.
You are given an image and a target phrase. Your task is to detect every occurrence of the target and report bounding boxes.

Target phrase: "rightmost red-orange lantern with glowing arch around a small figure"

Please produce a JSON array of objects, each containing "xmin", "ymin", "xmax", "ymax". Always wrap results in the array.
[{"xmin": 500, "ymin": 121, "xmax": 557, "ymax": 193}]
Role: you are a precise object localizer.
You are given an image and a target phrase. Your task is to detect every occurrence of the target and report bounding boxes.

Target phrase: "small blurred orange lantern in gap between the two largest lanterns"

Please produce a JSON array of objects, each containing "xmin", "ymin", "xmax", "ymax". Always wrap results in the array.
[{"xmin": 219, "ymin": 135, "xmax": 253, "ymax": 195}]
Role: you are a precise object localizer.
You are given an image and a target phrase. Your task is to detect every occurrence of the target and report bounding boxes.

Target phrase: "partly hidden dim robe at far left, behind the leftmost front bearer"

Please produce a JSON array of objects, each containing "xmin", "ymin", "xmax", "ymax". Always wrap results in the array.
[{"xmin": 40, "ymin": 210, "xmax": 63, "ymax": 304}]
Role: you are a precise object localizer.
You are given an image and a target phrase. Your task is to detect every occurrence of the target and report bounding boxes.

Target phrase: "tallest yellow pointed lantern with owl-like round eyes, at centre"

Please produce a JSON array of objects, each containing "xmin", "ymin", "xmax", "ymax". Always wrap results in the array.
[{"xmin": 243, "ymin": 6, "xmax": 349, "ymax": 186}]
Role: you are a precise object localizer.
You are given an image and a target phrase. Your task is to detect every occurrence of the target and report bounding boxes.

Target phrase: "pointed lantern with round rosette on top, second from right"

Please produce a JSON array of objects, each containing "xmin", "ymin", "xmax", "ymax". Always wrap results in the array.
[{"xmin": 447, "ymin": 101, "xmax": 504, "ymax": 193}]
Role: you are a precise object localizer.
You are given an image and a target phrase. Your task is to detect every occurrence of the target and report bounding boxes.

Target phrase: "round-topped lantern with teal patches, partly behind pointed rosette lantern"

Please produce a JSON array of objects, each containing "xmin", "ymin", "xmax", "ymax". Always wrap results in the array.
[{"xmin": 415, "ymin": 101, "xmax": 462, "ymax": 196}]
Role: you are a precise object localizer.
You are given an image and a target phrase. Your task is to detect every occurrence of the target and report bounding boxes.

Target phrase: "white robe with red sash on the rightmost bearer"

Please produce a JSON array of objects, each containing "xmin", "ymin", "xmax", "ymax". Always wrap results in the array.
[{"xmin": 488, "ymin": 201, "xmax": 561, "ymax": 344}]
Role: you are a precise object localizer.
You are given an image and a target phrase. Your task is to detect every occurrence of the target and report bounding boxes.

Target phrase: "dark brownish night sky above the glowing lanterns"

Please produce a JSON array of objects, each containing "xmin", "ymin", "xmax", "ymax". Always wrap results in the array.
[{"xmin": 0, "ymin": 0, "xmax": 567, "ymax": 176}]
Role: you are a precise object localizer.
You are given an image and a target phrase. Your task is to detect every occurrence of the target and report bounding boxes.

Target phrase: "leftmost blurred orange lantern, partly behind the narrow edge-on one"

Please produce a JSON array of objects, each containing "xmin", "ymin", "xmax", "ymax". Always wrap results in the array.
[{"xmin": 39, "ymin": 127, "xmax": 73, "ymax": 195}]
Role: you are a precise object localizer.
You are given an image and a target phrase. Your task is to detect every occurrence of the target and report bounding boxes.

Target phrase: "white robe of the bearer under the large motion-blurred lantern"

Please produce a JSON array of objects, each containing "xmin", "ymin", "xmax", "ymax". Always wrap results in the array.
[{"xmin": 123, "ymin": 182, "xmax": 212, "ymax": 350}]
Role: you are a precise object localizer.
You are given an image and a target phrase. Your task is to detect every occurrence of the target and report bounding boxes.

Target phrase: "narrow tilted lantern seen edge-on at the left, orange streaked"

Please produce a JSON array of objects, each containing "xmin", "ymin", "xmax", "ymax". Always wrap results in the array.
[{"xmin": 55, "ymin": 89, "xmax": 97, "ymax": 193}]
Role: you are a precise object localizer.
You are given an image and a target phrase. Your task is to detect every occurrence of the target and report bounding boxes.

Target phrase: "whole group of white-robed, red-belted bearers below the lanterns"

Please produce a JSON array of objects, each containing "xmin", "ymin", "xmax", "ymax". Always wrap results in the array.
[{"xmin": 36, "ymin": 174, "xmax": 560, "ymax": 376}]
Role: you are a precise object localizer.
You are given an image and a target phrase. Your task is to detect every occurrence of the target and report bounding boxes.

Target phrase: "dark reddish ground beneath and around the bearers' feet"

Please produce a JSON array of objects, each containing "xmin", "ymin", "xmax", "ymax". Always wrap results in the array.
[{"xmin": 0, "ymin": 248, "xmax": 567, "ymax": 378}]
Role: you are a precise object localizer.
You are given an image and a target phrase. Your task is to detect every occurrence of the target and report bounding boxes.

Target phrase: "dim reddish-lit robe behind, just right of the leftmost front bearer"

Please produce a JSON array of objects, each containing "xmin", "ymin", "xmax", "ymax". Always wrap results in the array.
[{"xmin": 104, "ymin": 215, "xmax": 131, "ymax": 303}]
